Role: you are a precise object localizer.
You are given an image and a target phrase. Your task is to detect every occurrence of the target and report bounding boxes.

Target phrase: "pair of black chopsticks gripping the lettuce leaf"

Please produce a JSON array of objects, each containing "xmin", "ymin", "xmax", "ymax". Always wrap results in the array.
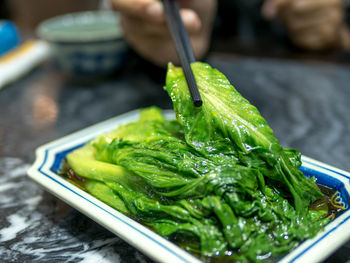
[{"xmin": 163, "ymin": 0, "xmax": 203, "ymax": 107}]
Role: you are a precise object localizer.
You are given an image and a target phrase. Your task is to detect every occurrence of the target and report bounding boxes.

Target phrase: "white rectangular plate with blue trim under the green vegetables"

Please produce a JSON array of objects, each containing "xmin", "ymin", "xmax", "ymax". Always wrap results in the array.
[{"xmin": 28, "ymin": 110, "xmax": 350, "ymax": 263}]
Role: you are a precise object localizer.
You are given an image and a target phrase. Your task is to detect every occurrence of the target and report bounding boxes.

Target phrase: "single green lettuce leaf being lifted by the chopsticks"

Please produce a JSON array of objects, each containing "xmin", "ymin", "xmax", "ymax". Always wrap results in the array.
[{"xmin": 165, "ymin": 62, "xmax": 322, "ymax": 214}]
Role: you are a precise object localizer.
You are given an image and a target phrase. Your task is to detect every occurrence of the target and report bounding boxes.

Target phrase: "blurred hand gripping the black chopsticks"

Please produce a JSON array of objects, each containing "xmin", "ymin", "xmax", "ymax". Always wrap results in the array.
[{"xmin": 110, "ymin": 0, "xmax": 217, "ymax": 66}]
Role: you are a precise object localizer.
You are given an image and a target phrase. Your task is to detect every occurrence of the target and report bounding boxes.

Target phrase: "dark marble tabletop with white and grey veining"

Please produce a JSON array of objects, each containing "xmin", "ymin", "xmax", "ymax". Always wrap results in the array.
[{"xmin": 0, "ymin": 54, "xmax": 350, "ymax": 263}]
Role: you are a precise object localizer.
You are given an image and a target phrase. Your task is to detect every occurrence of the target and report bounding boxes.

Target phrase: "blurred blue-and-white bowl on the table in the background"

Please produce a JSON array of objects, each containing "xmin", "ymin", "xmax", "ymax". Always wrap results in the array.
[{"xmin": 37, "ymin": 11, "xmax": 128, "ymax": 78}]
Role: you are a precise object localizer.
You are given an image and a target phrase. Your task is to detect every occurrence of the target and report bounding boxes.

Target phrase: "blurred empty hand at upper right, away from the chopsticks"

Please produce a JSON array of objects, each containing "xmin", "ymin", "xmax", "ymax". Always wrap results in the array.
[{"xmin": 262, "ymin": 0, "xmax": 346, "ymax": 50}]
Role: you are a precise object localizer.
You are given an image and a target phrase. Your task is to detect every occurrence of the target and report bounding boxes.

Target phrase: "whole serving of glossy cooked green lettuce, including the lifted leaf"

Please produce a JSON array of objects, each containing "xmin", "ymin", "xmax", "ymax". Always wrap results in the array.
[{"xmin": 67, "ymin": 63, "xmax": 328, "ymax": 262}]
